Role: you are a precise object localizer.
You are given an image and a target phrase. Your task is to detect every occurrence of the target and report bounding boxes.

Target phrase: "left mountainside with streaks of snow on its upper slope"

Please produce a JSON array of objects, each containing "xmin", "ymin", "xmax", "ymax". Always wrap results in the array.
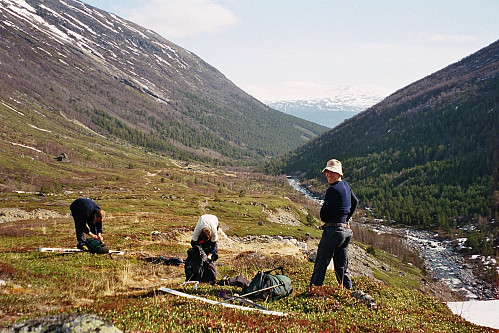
[{"xmin": 0, "ymin": 0, "xmax": 326, "ymax": 163}]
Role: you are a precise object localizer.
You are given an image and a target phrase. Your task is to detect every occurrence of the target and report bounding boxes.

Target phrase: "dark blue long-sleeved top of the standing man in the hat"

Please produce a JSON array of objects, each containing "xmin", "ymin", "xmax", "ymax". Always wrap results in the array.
[{"xmin": 320, "ymin": 180, "xmax": 359, "ymax": 223}]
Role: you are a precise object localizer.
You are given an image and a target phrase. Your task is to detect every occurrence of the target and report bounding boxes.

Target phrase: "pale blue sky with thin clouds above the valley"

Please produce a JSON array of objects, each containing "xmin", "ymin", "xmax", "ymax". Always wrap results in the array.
[{"xmin": 83, "ymin": 0, "xmax": 499, "ymax": 100}]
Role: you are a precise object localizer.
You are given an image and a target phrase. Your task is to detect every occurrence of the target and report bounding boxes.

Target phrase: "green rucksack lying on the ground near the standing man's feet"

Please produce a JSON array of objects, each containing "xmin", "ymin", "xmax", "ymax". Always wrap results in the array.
[{"xmin": 244, "ymin": 266, "xmax": 293, "ymax": 302}]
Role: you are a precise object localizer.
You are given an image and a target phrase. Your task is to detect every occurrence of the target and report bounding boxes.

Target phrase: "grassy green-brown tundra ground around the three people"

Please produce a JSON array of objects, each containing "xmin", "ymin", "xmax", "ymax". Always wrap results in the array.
[{"xmin": 0, "ymin": 160, "xmax": 492, "ymax": 332}]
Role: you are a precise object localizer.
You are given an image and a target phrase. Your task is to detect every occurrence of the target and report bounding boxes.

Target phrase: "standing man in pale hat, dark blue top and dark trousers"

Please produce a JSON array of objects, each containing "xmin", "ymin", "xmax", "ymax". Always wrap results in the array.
[{"xmin": 310, "ymin": 159, "xmax": 358, "ymax": 289}]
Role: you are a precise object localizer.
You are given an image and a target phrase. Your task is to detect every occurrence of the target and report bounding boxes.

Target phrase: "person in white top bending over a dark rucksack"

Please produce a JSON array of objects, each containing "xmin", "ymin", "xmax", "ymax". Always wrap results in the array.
[{"xmin": 185, "ymin": 214, "xmax": 219, "ymax": 284}]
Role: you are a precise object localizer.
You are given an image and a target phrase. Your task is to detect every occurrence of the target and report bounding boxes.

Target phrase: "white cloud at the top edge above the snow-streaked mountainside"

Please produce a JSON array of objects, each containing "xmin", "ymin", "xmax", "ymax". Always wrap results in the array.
[{"xmin": 126, "ymin": 0, "xmax": 238, "ymax": 39}]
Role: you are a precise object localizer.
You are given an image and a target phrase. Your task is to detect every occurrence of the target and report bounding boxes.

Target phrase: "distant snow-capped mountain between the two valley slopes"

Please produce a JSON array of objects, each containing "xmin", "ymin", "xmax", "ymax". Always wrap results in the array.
[{"xmin": 267, "ymin": 86, "xmax": 388, "ymax": 128}]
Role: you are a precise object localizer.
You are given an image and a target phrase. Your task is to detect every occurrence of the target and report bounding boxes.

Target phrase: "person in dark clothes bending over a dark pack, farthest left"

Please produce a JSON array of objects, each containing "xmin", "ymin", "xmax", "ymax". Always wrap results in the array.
[{"xmin": 69, "ymin": 198, "xmax": 109, "ymax": 254}]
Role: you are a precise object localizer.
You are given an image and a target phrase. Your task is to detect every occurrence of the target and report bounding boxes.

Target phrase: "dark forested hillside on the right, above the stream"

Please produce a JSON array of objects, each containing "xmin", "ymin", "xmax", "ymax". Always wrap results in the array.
[{"xmin": 267, "ymin": 42, "xmax": 499, "ymax": 233}]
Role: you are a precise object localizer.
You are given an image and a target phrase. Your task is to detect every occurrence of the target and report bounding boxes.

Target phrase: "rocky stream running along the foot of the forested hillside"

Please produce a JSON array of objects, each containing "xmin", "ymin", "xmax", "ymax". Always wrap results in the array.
[{"xmin": 288, "ymin": 178, "xmax": 494, "ymax": 300}]
